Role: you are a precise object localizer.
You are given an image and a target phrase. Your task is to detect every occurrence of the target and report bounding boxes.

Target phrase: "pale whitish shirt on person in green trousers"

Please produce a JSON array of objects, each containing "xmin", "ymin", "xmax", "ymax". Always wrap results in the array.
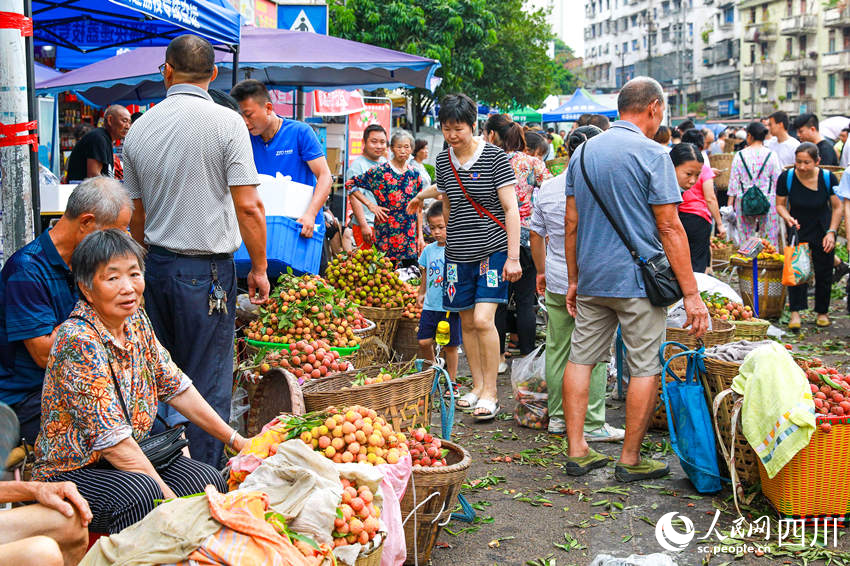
[{"xmin": 531, "ymin": 171, "xmax": 569, "ymax": 295}]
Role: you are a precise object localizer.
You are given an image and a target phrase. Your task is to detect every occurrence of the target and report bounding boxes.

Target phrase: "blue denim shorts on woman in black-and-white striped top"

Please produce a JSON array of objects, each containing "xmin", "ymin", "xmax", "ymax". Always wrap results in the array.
[{"xmin": 443, "ymin": 252, "xmax": 509, "ymax": 312}]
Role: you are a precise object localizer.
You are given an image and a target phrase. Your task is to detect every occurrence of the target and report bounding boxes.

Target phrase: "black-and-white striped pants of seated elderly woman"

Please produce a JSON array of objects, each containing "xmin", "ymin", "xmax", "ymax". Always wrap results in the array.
[{"xmin": 48, "ymin": 456, "xmax": 227, "ymax": 534}]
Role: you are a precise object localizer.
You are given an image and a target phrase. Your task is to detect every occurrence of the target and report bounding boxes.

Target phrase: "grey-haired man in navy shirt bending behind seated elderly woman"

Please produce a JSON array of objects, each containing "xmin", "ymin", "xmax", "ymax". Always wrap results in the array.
[{"xmin": 0, "ymin": 177, "xmax": 133, "ymax": 444}]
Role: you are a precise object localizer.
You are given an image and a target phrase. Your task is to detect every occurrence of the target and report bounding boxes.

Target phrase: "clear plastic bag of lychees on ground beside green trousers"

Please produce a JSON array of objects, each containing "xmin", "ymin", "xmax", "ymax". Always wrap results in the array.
[{"xmin": 511, "ymin": 345, "xmax": 549, "ymax": 430}]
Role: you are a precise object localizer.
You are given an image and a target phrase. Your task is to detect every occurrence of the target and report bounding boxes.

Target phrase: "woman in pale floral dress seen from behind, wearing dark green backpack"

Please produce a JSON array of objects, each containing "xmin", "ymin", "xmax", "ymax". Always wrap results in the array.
[{"xmin": 728, "ymin": 122, "xmax": 782, "ymax": 249}]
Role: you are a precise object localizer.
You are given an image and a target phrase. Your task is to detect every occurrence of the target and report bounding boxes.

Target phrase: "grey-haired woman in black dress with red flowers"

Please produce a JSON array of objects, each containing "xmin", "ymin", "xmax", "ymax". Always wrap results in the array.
[{"xmin": 345, "ymin": 130, "xmax": 425, "ymax": 266}]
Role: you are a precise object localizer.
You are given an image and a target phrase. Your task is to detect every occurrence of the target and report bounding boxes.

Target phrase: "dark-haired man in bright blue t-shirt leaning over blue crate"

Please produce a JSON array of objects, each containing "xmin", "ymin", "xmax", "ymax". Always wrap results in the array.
[{"xmin": 230, "ymin": 79, "xmax": 333, "ymax": 238}]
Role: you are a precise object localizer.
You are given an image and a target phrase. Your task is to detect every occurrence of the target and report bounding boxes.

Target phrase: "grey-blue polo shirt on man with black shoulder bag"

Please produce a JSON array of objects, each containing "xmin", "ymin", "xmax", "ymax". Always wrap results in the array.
[{"xmin": 565, "ymin": 120, "xmax": 682, "ymax": 298}]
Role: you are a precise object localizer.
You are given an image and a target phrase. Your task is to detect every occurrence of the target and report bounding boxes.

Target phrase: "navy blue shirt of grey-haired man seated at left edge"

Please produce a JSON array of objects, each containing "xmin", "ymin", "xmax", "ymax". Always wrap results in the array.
[{"xmin": 0, "ymin": 232, "xmax": 77, "ymax": 405}]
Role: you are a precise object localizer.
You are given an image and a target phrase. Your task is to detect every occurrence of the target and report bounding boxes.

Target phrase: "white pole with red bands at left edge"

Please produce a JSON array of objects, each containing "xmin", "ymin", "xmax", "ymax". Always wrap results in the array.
[{"xmin": 0, "ymin": 0, "xmax": 35, "ymax": 263}]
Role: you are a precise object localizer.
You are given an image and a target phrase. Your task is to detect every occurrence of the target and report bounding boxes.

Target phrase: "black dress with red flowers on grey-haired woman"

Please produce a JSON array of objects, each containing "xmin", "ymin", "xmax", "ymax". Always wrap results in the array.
[{"xmin": 345, "ymin": 161, "xmax": 422, "ymax": 261}]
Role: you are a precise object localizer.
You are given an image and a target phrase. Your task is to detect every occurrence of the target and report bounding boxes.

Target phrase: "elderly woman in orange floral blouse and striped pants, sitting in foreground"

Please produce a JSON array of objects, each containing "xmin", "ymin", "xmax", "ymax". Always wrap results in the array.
[{"xmin": 33, "ymin": 229, "xmax": 246, "ymax": 533}]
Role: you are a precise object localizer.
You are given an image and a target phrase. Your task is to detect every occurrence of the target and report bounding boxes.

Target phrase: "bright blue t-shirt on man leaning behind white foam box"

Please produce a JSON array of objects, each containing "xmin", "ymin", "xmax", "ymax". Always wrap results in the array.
[{"xmin": 251, "ymin": 119, "xmax": 325, "ymax": 187}]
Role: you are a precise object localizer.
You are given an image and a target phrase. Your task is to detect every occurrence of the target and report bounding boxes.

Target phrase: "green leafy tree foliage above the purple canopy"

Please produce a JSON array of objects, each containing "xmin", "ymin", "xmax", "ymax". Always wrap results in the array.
[{"xmin": 328, "ymin": 0, "xmax": 557, "ymax": 107}]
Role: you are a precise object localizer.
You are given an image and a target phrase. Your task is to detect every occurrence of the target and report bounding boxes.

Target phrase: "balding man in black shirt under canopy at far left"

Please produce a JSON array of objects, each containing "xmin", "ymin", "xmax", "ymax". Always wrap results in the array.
[{"xmin": 68, "ymin": 104, "xmax": 131, "ymax": 182}]
